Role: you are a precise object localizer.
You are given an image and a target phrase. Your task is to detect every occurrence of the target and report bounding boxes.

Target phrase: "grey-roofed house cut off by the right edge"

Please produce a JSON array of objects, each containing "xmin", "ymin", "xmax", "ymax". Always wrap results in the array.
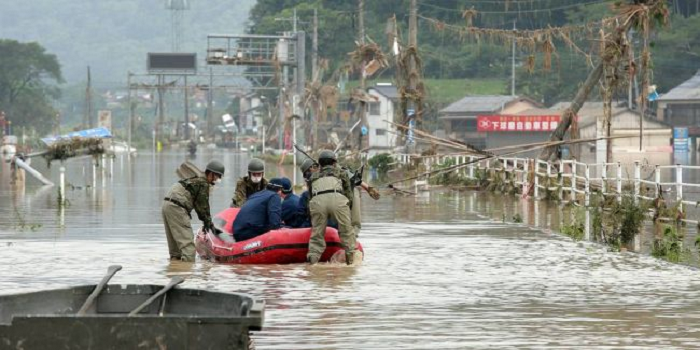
[{"xmin": 656, "ymin": 70, "xmax": 700, "ymax": 138}]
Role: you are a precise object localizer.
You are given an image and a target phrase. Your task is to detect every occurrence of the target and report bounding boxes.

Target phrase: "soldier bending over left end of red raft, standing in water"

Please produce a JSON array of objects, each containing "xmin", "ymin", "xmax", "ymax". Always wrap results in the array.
[{"xmin": 162, "ymin": 160, "xmax": 224, "ymax": 261}]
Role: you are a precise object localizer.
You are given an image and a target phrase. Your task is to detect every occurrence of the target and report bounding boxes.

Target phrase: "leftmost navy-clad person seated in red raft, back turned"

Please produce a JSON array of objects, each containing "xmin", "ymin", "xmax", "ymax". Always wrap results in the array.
[{"xmin": 233, "ymin": 178, "xmax": 282, "ymax": 242}]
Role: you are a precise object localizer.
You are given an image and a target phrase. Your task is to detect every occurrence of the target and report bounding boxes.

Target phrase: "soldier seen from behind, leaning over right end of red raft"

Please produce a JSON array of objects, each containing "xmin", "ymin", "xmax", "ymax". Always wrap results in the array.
[{"xmin": 306, "ymin": 150, "xmax": 355, "ymax": 265}]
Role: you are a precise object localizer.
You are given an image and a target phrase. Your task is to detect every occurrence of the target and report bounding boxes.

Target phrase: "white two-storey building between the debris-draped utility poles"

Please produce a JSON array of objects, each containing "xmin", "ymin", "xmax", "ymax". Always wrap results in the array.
[{"xmin": 367, "ymin": 85, "xmax": 399, "ymax": 154}]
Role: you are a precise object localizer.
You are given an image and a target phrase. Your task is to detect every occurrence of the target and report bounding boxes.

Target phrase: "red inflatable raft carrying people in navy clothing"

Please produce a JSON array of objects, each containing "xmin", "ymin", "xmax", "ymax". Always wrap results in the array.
[{"xmin": 195, "ymin": 208, "xmax": 364, "ymax": 264}]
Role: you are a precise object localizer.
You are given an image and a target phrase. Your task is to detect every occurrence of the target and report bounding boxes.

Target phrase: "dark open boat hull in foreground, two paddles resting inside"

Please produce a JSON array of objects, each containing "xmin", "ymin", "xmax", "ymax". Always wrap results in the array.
[{"xmin": 0, "ymin": 285, "xmax": 265, "ymax": 350}]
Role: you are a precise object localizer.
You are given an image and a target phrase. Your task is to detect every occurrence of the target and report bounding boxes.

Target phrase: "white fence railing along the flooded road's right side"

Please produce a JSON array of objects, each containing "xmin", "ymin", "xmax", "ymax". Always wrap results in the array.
[{"xmin": 394, "ymin": 154, "xmax": 700, "ymax": 223}]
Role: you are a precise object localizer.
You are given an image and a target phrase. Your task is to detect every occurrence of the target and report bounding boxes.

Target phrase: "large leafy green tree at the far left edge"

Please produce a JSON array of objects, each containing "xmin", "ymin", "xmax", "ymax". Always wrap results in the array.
[{"xmin": 0, "ymin": 39, "xmax": 63, "ymax": 132}]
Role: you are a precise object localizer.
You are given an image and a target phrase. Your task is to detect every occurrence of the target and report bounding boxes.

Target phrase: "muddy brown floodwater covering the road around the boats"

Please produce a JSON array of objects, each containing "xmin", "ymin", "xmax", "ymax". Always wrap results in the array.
[{"xmin": 0, "ymin": 151, "xmax": 700, "ymax": 349}]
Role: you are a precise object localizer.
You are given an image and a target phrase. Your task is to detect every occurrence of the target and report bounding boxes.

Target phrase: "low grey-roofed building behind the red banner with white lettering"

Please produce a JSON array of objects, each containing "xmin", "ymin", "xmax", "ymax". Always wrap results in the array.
[{"xmin": 438, "ymin": 95, "xmax": 540, "ymax": 147}]
